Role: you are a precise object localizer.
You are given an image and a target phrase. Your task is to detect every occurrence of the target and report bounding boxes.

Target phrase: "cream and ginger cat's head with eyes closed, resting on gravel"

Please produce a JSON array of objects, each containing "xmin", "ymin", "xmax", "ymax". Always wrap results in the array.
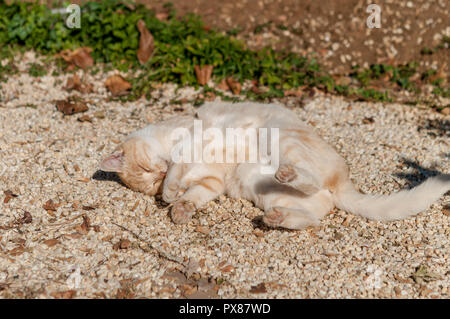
[{"xmin": 100, "ymin": 137, "xmax": 168, "ymax": 195}]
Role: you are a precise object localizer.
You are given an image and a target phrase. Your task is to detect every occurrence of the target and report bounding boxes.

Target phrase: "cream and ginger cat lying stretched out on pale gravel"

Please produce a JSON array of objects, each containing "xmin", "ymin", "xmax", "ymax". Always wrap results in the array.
[{"xmin": 100, "ymin": 102, "xmax": 450, "ymax": 229}]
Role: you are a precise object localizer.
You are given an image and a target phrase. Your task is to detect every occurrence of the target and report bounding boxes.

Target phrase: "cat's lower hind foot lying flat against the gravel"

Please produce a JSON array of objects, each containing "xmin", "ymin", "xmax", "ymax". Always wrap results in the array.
[{"xmin": 263, "ymin": 207, "xmax": 320, "ymax": 229}]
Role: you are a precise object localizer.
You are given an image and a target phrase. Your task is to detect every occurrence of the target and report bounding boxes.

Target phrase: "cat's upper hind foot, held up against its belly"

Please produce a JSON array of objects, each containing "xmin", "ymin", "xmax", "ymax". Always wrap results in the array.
[{"xmin": 275, "ymin": 164, "xmax": 321, "ymax": 196}]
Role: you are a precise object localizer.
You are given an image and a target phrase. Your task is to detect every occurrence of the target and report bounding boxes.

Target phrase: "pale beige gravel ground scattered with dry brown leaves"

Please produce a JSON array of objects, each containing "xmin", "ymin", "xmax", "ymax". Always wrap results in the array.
[{"xmin": 0, "ymin": 53, "xmax": 450, "ymax": 298}]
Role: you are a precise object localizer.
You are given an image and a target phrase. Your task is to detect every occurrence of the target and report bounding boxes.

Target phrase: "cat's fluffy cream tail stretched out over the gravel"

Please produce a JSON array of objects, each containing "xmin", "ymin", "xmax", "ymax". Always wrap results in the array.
[{"xmin": 334, "ymin": 174, "xmax": 450, "ymax": 221}]
